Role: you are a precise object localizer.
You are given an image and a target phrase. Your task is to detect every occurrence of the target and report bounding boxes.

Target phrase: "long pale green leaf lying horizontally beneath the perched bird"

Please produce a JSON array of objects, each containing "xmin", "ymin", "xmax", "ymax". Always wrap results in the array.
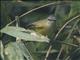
[{"xmin": 1, "ymin": 26, "xmax": 49, "ymax": 42}]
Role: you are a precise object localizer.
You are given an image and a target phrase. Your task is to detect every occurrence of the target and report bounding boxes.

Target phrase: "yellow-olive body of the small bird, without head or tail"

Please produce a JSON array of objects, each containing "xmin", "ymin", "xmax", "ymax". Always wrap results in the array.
[{"xmin": 33, "ymin": 19, "xmax": 51, "ymax": 35}]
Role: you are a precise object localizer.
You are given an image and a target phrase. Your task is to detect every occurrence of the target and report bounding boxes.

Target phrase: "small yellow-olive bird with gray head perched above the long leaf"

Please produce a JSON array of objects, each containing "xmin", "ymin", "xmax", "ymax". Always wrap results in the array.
[{"xmin": 28, "ymin": 15, "xmax": 56, "ymax": 36}]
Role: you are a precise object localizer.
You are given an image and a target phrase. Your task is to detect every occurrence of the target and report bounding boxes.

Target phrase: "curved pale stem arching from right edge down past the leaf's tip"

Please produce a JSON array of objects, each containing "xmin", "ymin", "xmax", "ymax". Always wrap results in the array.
[{"xmin": 46, "ymin": 15, "xmax": 80, "ymax": 58}]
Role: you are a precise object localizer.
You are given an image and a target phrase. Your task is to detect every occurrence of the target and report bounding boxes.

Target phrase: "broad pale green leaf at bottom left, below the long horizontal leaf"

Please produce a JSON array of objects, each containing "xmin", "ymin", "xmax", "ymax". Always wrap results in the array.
[{"xmin": 5, "ymin": 42, "xmax": 33, "ymax": 60}]
